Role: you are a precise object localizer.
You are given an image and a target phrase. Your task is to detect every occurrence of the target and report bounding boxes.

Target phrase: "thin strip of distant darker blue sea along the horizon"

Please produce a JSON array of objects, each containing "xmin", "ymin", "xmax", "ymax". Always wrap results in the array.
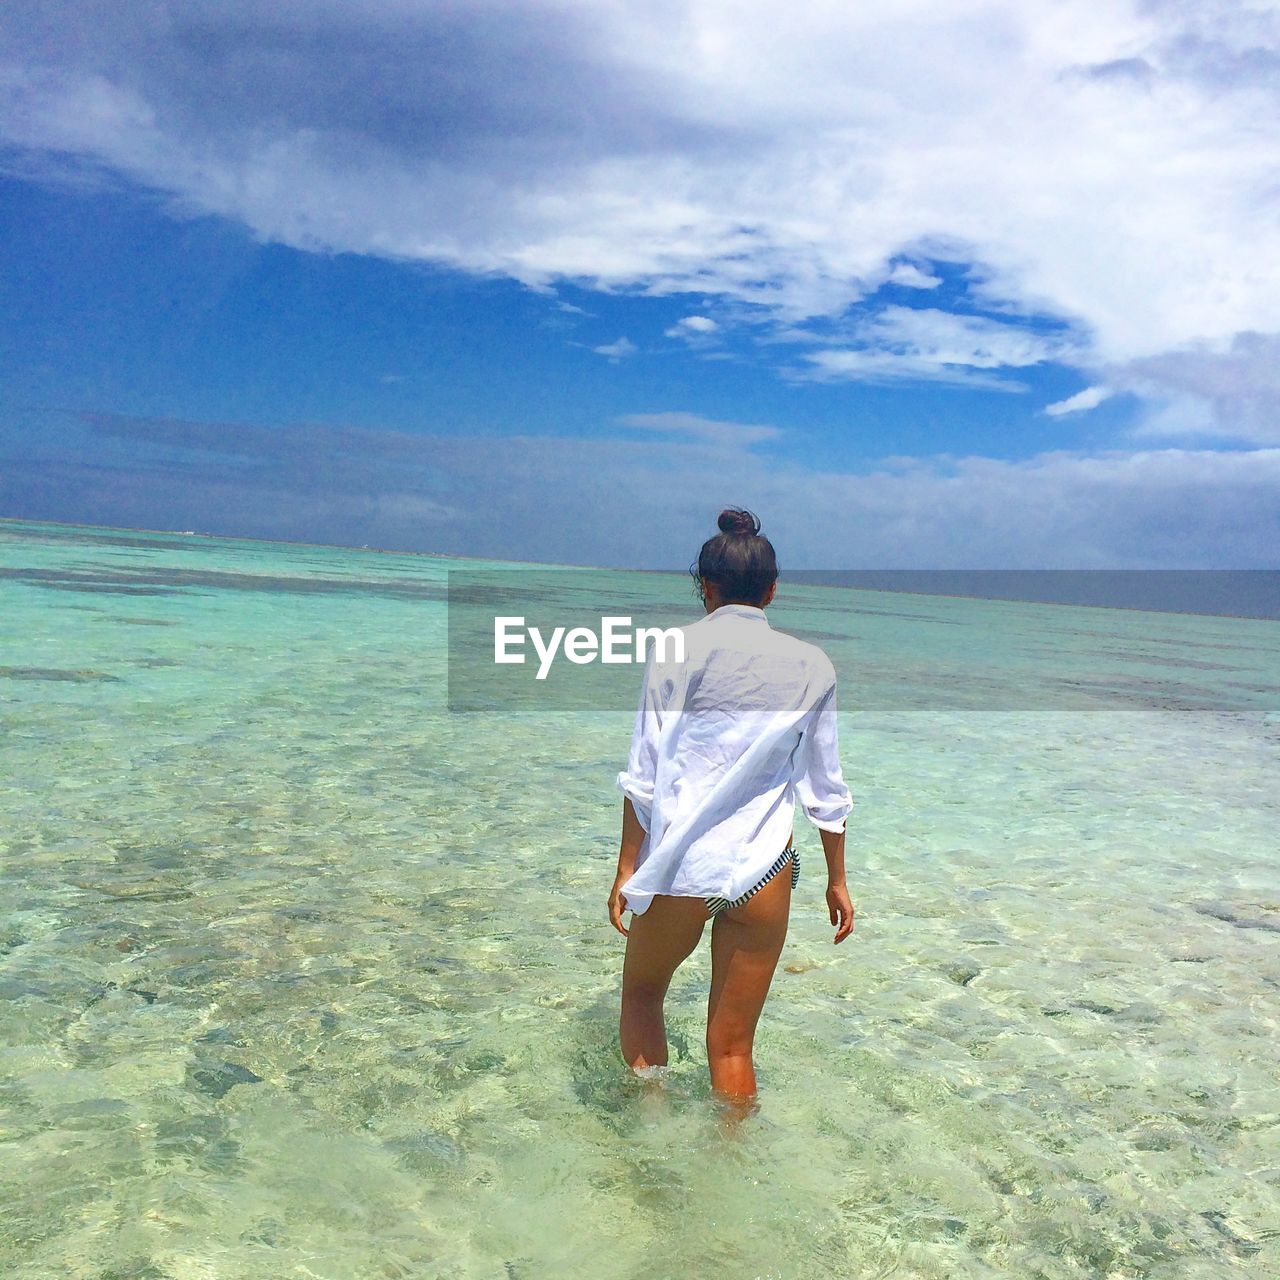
[{"xmin": 0, "ymin": 516, "xmax": 1280, "ymax": 622}]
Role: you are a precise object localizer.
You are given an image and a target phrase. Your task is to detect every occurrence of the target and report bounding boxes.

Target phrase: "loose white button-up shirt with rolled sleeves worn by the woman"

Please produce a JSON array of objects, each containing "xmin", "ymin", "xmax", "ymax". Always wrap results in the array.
[{"xmin": 618, "ymin": 604, "xmax": 854, "ymax": 914}]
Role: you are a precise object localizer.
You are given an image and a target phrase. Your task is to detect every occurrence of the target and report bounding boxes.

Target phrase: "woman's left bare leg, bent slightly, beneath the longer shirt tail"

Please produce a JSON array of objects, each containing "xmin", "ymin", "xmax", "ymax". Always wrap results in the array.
[{"xmin": 618, "ymin": 893, "xmax": 707, "ymax": 1070}]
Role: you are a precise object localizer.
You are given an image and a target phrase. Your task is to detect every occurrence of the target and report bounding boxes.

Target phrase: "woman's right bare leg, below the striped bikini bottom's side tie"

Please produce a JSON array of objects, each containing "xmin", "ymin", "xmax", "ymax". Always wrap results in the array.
[{"xmin": 707, "ymin": 867, "xmax": 791, "ymax": 1101}]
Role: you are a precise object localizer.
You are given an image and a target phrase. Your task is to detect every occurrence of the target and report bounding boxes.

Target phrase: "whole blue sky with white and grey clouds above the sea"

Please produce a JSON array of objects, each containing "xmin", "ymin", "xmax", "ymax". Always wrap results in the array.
[{"xmin": 0, "ymin": 0, "xmax": 1280, "ymax": 568}]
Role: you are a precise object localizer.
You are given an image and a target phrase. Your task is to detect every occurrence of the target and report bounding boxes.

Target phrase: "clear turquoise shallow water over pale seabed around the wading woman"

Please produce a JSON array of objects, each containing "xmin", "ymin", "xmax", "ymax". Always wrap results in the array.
[{"xmin": 0, "ymin": 522, "xmax": 1280, "ymax": 1280}]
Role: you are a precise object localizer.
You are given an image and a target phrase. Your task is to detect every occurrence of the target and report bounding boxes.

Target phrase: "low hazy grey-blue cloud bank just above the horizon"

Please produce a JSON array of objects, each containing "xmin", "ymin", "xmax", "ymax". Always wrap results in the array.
[{"xmin": 0, "ymin": 413, "xmax": 1280, "ymax": 568}]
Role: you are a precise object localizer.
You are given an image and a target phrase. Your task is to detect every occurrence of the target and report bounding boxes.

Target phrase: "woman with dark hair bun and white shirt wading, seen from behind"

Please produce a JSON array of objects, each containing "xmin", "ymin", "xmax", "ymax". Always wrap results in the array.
[{"xmin": 609, "ymin": 509, "xmax": 854, "ymax": 1102}]
